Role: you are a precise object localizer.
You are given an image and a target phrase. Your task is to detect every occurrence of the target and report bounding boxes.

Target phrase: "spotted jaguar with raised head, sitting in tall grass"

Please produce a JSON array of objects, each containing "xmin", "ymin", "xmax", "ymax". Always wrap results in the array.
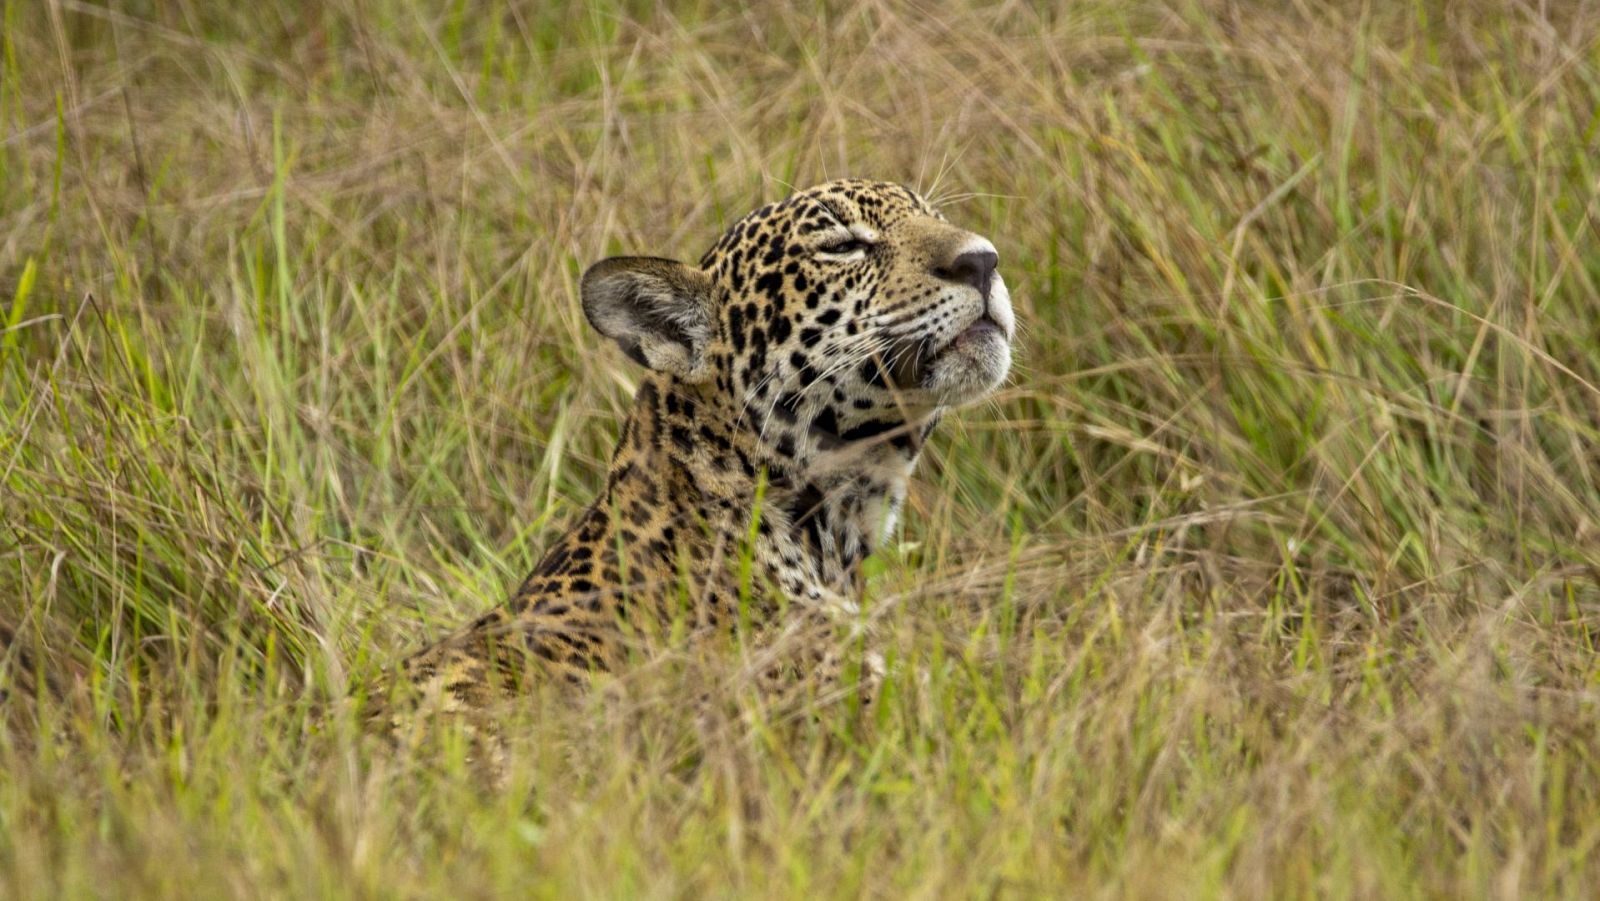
[{"xmin": 382, "ymin": 181, "xmax": 1014, "ymax": 748}]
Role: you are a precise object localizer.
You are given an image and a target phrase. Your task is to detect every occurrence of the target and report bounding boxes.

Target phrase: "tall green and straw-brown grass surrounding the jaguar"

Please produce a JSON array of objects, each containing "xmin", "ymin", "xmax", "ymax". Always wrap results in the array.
[{"xmin": 0, "ymin": 0, "xmax": 1600, "ymax": 898}]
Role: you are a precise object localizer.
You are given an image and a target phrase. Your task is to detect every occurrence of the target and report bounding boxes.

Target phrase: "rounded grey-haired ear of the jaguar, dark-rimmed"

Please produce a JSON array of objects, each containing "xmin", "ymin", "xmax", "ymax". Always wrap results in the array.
[{"xmin": 579, "ymin": 256, "xmax": 712, "ymax": 382}]
